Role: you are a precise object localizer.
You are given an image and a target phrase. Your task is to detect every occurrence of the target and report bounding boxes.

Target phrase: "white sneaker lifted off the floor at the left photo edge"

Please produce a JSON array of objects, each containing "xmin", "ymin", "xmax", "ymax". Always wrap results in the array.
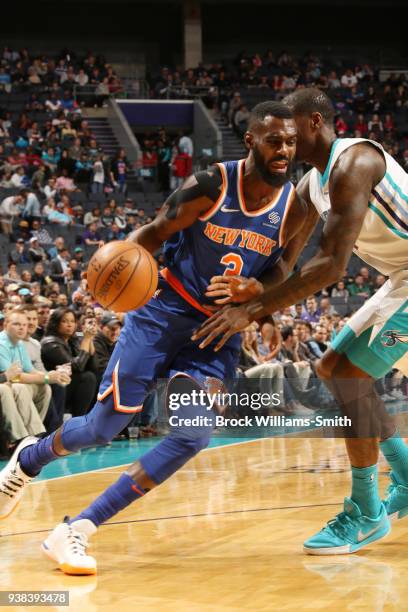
[{"xmin": 0, "ymin": 436, "xmax": 38, "ymax": 519}]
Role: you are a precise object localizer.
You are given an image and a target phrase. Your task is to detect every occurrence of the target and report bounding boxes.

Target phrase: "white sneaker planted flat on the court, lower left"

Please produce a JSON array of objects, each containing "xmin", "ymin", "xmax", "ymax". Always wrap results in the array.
[{"xmin": 41, "ymin": 519, "xmax": 96, "ymax": 576}]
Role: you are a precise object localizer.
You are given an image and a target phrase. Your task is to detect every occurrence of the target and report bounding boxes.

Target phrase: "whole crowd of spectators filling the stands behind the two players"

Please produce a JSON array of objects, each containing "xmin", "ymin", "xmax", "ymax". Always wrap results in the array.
[{"xmin": 0, "ymin": 50, "xmax": 407, "ymax": 454}]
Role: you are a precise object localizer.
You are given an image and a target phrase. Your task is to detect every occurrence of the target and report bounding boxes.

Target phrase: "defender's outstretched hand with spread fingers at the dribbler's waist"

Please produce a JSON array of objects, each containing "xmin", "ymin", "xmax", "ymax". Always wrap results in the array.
[{"xmin": 191, "ymin": 304, "xmax": 254, "ymax": 351}]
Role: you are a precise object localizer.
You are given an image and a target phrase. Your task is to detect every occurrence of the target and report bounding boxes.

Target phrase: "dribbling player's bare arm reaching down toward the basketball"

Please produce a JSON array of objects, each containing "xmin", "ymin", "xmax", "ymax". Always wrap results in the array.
[{"xmin": 129, "ymin": 166, "xmax": 223, "ymax": 253}]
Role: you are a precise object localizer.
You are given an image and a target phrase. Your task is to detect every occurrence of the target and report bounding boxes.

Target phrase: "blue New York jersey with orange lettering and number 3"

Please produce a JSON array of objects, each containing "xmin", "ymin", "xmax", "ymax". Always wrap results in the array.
[{"xmin": 163, "ymin": 159, "xmax": 295, "ymax": 309}]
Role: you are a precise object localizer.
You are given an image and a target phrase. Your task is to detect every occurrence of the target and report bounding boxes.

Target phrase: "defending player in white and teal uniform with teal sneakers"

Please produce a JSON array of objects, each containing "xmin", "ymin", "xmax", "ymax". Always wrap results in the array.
[{"xmin": 195, "ymin": 88, "xmax": 408, "ymax": 554}]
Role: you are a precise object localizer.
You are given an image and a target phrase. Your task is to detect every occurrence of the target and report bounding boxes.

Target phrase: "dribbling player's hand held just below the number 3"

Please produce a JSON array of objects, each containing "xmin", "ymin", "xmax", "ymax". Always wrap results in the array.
[{"xmin": 205, "ymin": 276, "xmax": 264, "ymax": 306}]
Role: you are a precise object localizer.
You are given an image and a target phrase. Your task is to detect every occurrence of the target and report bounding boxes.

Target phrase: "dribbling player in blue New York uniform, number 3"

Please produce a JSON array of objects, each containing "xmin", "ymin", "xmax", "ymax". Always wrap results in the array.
[{"xmin": 0, "ymin": 102, "xmax": 316, "ymax": 574}]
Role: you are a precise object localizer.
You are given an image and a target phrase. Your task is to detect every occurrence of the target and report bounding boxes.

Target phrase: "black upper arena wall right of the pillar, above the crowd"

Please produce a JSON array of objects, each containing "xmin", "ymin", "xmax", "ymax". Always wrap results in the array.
[{"xmin": 202, "ymin": 0, "xmax": 408, "ymax": 63}]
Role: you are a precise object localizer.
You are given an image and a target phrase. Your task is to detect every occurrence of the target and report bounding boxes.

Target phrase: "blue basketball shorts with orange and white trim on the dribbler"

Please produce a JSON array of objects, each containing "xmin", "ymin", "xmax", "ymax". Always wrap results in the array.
[{"xmin": 98, "ymin": 279, "xmax": 240, "ymax": 413}]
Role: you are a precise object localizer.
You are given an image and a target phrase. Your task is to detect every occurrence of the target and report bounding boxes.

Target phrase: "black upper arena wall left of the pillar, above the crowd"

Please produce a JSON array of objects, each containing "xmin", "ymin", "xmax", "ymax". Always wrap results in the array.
[{"xmin": 0, "ymin": 0, "xmax": 183, "ymax": 65}]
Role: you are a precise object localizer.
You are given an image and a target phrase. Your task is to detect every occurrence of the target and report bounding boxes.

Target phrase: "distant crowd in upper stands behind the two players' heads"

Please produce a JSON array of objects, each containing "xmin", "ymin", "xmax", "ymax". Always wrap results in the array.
[{"xmin": 149, "ymin": 50, "xmax": 408, "ymax": 169}]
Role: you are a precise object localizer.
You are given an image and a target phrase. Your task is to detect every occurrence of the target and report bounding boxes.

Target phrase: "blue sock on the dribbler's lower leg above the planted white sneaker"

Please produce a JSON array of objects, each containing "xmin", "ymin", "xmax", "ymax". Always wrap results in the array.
[{"xmin": 69, "ymin": 473, "xmax": 147, "ymax": 527}]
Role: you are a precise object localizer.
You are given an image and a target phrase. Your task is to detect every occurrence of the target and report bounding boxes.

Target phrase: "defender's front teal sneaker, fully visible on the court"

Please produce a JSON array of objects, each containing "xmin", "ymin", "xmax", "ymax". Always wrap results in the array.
[{"xmin": 303, "ymin": 497, "xmax": 391, "ymax": 555}]
